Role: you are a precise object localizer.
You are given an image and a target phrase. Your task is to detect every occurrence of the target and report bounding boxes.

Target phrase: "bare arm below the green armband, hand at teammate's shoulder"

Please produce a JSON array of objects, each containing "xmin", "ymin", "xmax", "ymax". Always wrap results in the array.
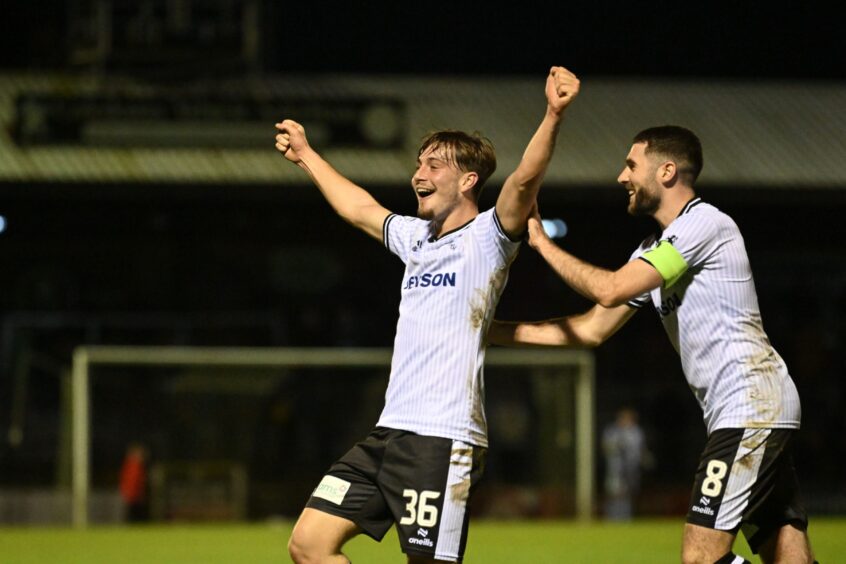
[{"xmin": 529, "ymin": 210, "xmax": 664, "ymax": 308}]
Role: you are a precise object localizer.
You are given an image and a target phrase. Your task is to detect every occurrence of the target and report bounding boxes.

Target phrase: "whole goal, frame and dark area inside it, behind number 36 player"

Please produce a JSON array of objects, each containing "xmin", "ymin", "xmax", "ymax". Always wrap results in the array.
[{"xmin": 69, "ymin": 346, "xmax": 595, "ymax": 527}]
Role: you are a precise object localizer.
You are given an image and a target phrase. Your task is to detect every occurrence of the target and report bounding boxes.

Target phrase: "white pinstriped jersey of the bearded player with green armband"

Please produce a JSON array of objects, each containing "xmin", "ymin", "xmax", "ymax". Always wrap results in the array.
[{"xmin": 629, "ymin": 198, "xmax": 801, "ymax": 433}]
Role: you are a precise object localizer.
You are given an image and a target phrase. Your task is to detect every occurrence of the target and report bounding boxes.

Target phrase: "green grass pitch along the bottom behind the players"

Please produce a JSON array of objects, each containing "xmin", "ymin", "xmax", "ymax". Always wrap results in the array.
[{"xmin": 0, "ymin": 517, "xmax": 846, "ymax": 564}]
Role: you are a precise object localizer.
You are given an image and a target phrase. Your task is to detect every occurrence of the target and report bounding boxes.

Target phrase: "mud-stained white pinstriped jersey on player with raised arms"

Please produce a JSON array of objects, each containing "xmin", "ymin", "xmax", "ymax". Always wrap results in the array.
[{"xmin": 377, "ymin": 208, "xmax": 520, "ymax": 447}]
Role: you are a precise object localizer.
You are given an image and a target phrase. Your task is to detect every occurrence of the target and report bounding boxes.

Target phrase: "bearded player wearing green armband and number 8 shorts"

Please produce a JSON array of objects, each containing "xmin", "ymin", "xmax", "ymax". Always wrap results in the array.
[{"xmin": 489, "ymin": 125, "xmax": 814, "ymax": 564}]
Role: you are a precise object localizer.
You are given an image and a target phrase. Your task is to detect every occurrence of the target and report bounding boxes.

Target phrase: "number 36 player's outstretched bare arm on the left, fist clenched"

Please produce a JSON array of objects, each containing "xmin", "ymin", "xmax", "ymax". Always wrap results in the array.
[{"xmin": 276, "ymin": 119, "xmax": 391, "ymax": 241}]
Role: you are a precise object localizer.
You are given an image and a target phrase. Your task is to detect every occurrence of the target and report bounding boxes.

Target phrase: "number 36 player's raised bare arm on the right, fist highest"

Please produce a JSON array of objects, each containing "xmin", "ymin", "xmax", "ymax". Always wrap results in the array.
[{"xmin": 496, "ymin": 67, "xmax": 579, "ymax": 239}]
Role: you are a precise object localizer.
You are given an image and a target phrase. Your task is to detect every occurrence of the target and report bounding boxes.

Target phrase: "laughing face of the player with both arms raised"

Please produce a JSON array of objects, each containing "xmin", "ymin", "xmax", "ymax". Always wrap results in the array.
[{"xmin": 411, "ymin": 146, "xmax": 474, "ymax": 221}]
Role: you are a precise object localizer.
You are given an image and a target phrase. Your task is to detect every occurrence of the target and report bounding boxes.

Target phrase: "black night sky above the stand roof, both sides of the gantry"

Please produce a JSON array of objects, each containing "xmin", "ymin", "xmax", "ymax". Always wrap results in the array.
[{"xmin": 0, "ymin": 0, "xmax": 846, "ymax": 80}]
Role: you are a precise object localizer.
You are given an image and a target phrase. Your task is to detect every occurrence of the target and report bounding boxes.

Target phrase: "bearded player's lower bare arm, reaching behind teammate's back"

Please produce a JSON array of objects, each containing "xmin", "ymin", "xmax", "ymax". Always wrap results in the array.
[{"xmin": 488, "ymin": 305, "xmax": 638, "ymax": 347}]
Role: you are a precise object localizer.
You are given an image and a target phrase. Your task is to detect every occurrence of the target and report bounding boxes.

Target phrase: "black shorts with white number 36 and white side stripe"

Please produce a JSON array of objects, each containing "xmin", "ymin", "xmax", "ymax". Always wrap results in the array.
[{"xmin": 306, "ymin": 427, "xmax": 487, "ymax": 561}]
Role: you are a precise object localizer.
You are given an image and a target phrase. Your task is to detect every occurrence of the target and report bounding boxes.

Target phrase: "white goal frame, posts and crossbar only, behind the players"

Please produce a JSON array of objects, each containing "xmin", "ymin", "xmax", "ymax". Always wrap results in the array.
[{"xmin": 71, "ymin": 346, "xmax": 595, "ymax": 527}]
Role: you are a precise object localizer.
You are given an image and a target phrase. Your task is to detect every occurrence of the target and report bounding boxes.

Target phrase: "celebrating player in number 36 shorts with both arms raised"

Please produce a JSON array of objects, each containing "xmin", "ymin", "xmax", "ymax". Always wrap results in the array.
[{"xmin": 276, "ymin": 67, "xmax": 579, "ymax": 563}]
